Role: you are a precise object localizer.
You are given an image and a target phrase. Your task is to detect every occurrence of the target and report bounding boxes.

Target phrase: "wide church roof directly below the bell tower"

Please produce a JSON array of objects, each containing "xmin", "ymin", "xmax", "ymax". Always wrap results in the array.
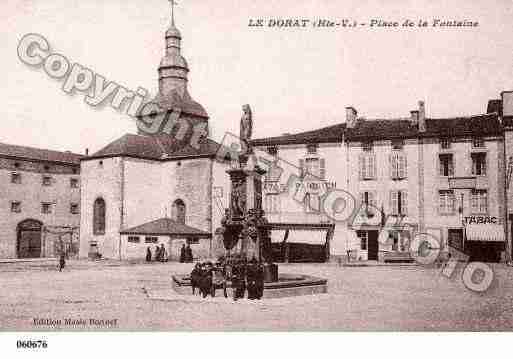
[{"xmin": 84, "ymin": 134, "xmax": 220, "ymax": 160}]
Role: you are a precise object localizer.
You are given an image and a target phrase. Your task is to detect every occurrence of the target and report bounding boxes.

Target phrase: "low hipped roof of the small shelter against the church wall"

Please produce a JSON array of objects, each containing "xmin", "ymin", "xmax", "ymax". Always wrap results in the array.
[{"xmin": 119, "ymin": 218, "xmax": 210, "ymax": 237}]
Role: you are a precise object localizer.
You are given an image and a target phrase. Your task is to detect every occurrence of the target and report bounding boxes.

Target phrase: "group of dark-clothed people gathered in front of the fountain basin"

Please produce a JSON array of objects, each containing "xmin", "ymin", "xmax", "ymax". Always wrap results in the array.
[{"xmin": 190, "ymin": 258, "xmax": 264, "ymax": 301}]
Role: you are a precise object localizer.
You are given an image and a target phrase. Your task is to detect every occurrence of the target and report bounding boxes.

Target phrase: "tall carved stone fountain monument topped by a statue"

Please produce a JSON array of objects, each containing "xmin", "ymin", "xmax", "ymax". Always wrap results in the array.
[{"xmin": 172, "ymin": 105, "xmax": 328, "ymax": 298}]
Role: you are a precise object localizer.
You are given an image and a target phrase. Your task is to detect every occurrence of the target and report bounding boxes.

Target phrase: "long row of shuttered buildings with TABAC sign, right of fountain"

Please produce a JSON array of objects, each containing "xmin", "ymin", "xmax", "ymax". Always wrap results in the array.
[{"xmin": 253, "ymin": 99, "xmax": 513, "ymax": 261}]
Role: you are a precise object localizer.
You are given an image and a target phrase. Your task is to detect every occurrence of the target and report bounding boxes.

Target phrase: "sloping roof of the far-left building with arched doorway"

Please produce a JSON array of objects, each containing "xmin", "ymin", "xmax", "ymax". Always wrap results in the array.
[{"xmin": 0, "ymin": 143, "xmax": 83, "ymax": 165}]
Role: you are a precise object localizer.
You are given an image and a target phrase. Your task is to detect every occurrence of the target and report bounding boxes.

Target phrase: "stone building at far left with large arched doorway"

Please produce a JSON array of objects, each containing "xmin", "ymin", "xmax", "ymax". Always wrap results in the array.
[{"xmin": 0, "ymin": 143, "xmax": 82, "ymax": 258}]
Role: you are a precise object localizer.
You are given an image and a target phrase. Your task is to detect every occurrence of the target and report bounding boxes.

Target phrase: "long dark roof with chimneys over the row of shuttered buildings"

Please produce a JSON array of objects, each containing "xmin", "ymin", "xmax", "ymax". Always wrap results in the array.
[{"xmin": 252, "ymin": 113, "xmax": 503, "ymax": 146}]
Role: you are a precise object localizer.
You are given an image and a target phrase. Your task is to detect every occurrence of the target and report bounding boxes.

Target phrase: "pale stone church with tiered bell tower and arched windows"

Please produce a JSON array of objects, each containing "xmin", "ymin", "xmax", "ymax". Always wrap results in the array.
[{"xmin": 80, "ymin": 14, "xmax": 229, "ymax": 260}]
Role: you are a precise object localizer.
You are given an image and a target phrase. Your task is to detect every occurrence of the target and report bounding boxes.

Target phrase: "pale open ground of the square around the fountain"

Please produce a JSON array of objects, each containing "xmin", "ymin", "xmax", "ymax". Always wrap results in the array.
[{"xmin": 0, "ymin": 261, "xmax": 513, "ymax": 331}]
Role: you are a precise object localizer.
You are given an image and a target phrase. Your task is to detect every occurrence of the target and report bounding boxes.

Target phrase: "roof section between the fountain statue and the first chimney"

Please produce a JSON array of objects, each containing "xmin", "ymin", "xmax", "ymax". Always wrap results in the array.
[{"xmin": 251, "ymin": 123, "xmax": 346, "ymax": 146}]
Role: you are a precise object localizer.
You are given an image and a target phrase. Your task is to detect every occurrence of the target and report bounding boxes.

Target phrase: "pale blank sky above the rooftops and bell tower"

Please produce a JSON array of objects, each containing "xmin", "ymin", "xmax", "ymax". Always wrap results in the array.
[{"xmin": 0, "ymin": 0, "xmax": 513, "ymax": 153}]
